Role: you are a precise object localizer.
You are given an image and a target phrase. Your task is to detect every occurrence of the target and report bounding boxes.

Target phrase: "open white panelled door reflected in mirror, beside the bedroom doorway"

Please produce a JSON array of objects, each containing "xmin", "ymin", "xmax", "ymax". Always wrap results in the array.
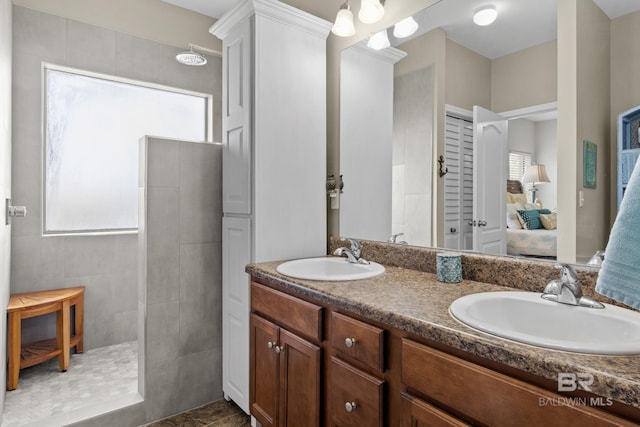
[{"xmin": 473, "ymin": 106, "xmax": 508, "ymax": 255}]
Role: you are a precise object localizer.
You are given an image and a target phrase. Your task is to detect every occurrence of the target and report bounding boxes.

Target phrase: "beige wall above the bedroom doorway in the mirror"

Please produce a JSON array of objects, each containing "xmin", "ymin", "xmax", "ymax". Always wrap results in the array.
[{"xmin": 491, "ymin": 40, "xmax": 558, "ymax": 111}]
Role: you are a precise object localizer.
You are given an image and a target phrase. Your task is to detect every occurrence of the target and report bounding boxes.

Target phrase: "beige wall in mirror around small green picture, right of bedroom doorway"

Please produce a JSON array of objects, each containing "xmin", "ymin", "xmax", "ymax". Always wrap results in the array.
[{"xmin": 558, "ymin": 0, "xmax": 611, "ymax": 262}]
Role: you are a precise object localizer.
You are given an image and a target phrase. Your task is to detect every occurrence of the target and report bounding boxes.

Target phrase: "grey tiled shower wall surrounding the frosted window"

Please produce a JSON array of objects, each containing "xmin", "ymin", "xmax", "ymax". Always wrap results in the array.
[{"xmin": 11, "ymin": 5, "xmax": 222, "ymax": 349}]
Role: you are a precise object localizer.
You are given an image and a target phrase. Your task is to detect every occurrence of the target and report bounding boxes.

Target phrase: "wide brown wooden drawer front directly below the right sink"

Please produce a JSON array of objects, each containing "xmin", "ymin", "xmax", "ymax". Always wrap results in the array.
[{"xmin": 402, "ymin": 339, "xmax": 634, "ymax": 427}]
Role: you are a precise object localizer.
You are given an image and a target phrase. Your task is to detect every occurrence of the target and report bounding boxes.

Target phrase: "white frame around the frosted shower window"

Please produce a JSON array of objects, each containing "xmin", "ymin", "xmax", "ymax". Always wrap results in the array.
[{"xmin": 40, "ymin": 62, "xmax": 213, "ymax": 237}]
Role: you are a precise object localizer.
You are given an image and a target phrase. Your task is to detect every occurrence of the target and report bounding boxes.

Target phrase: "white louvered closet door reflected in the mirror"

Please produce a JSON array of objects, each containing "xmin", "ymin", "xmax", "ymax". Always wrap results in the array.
[{"xmin": 444, "ymin": 116, "xmax": 473, "ymax": 249}]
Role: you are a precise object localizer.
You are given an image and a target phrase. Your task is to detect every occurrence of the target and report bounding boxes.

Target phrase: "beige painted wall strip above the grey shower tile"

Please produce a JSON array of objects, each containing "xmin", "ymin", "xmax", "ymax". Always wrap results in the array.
[{"xmin": 13, "ymin": 0, "xmax": 222, "ymax": 52}]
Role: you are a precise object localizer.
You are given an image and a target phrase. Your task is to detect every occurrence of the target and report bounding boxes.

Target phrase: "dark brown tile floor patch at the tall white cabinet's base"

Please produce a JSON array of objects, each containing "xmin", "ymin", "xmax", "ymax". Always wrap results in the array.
[{"xmin": 147, "ymin": 399, "xmax": 251, "ymax": 427}]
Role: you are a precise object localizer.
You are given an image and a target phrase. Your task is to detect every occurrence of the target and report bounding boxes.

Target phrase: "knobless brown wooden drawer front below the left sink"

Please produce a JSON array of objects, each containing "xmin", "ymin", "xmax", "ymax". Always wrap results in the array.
[{"xmin": 251, "ymin": 282, "xmax": 324, "ymax": 341}]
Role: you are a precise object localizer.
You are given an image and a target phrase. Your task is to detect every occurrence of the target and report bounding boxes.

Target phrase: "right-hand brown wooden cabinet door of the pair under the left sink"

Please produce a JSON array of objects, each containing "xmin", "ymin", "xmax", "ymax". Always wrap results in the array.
[{"xmin": 279, "ymin": 329, "xmax": 320, "ymax": 427}]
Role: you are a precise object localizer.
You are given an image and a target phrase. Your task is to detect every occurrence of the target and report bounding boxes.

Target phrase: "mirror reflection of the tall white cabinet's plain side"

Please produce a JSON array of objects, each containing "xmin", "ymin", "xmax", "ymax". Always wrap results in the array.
[{"xmin": 340, "ymin": 44, "xmax": 398, "ymax": 241}]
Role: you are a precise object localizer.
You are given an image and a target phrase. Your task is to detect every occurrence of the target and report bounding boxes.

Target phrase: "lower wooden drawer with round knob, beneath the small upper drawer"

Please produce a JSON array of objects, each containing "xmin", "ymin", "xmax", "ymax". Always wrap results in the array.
[{"xmin": 327, "ymin": 356, "xmax": 384, "ymax": 427}]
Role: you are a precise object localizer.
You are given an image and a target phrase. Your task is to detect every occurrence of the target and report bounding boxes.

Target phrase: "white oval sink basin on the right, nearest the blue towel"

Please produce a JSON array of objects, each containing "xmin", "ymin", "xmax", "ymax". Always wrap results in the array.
[{"xmin": 449, "ymin": 292, "xmax": 640, "ymax": 355}]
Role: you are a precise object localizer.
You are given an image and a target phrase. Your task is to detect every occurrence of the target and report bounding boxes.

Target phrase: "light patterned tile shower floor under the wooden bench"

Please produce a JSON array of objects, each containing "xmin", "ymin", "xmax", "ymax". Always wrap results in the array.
[{"xmin": 2, "ymin": 341, "xmax": 138, "ymax": 427}]
